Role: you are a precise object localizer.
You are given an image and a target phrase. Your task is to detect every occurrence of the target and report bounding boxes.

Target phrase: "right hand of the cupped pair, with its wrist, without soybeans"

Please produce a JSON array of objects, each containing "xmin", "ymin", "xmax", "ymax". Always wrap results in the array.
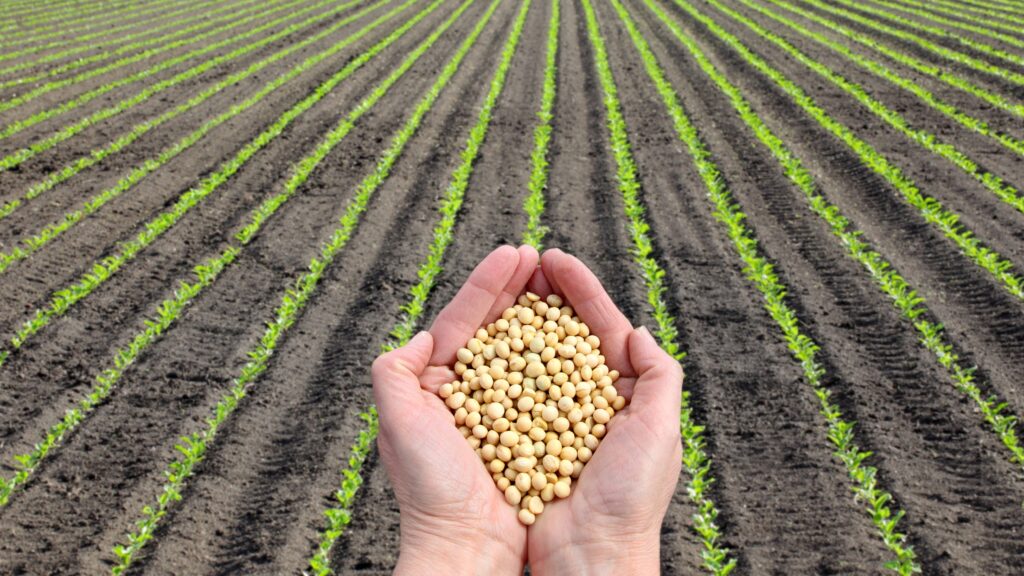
[{"xmin": 528, "ymin": 250, "xmax": 683, "ymax": 576}]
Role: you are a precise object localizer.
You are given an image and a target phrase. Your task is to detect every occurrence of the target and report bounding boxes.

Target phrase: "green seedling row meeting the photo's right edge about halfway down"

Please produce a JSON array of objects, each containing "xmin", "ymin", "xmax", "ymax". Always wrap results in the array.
[{"xmin": 683, "ymin": 0, "xmax": 1024, "ymax": 299}]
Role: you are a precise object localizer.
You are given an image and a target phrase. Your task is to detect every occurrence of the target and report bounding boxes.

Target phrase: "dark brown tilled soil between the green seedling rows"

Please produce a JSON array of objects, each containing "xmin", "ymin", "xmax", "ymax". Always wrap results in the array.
[{"xmin": 0, "ymin": 0, "xmax": 1024, "ymax": 575}]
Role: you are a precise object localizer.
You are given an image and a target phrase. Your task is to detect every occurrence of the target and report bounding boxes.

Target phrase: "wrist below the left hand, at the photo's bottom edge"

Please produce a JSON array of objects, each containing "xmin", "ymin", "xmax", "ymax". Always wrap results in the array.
[{"xmin": 394, "ymin": 518, "xmax": 525, "ymax": 576}]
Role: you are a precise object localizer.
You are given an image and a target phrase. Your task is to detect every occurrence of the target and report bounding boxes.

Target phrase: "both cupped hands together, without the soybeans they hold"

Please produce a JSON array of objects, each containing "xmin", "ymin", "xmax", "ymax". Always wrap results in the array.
[{"xmin": 373, "ymin": 246, "xmax": 682, "ymax": 576}]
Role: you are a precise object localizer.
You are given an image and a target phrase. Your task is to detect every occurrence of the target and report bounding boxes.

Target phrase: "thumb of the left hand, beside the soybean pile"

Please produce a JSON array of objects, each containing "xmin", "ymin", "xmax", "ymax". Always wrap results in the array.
[{"xmin": 371, "ymin": 331, "xmax": 434, "ymax": 421}]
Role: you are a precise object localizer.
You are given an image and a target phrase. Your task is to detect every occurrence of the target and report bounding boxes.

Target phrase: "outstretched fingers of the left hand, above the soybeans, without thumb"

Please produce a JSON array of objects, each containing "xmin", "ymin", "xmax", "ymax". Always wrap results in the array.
[{"xmin": 430, "ymin": 246, "xmax": 520, "ymax": 365}]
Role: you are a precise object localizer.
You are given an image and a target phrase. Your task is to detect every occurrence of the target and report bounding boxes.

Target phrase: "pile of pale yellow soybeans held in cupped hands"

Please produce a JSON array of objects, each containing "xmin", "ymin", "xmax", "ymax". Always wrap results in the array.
[{"xmin": 439, "ymin": 292, "xmax": 626, "ymax": 526}]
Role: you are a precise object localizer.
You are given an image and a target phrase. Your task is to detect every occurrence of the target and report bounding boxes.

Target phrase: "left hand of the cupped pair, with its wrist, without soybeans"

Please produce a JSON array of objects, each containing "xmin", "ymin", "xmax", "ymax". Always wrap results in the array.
[{"xmin": 373, "ymin": 246, "xmax": 539, "ymax": 576}]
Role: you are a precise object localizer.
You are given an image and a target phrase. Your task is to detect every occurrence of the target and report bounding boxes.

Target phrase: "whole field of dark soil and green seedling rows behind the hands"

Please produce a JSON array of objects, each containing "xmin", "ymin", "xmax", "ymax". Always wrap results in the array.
[{"xmin": 0, "ymin": 0, "xmax": 1024, "ymax": 575}]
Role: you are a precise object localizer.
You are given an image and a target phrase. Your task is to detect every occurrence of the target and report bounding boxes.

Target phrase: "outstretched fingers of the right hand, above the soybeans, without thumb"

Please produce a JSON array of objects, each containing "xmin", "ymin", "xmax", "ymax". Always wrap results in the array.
[{"xmin": 541, "ymin": 249, "xmax": 633, "ymax": 377}]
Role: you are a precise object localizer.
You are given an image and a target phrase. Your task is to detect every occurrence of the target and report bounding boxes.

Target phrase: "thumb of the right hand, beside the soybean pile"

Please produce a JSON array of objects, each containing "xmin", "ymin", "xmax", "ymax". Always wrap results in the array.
[{"xmin": 629, "ymin": 327, "xmax": 683, "ymax": 420}]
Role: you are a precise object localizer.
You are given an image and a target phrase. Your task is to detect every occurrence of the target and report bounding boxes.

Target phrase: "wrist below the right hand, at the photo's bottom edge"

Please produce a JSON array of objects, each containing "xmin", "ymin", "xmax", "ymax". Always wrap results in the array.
[{"xmin": 529, "ymin": 533, "xmax": 662, "ymax": 576}]
